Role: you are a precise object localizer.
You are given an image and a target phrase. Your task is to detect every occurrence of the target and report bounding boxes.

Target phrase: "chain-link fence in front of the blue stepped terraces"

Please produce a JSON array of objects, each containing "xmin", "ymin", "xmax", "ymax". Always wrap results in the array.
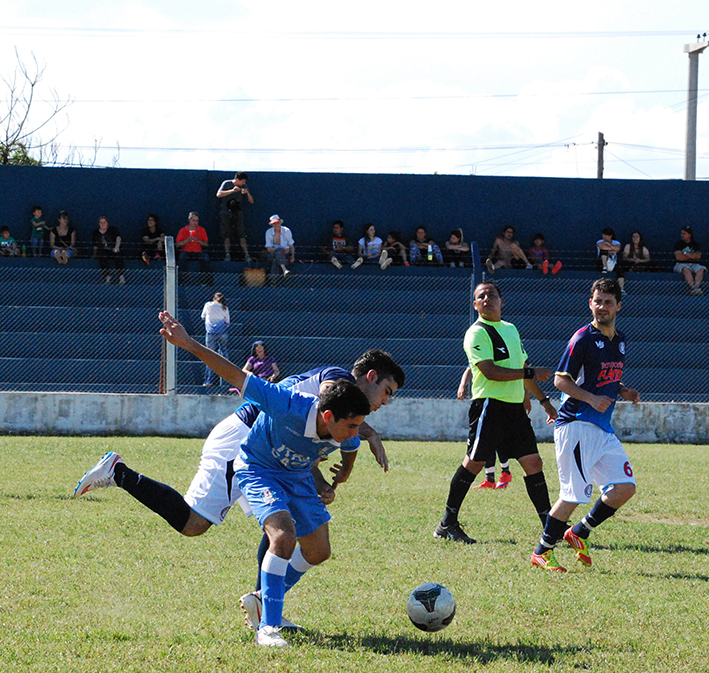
[{"xmin": 0, "ymin": 253, "xmax": 709, "ymax": 402}]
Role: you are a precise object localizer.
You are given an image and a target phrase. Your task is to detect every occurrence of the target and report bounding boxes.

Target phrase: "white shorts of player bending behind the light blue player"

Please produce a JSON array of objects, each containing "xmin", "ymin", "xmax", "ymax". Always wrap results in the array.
[{"xmin": 185, "ymin": 414, "xmax": 252, "ymax": 525}]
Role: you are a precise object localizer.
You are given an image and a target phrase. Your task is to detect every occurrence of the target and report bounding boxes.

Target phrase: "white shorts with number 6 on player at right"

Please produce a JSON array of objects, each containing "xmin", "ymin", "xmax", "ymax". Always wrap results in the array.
[{"xmin": 554, "ymin": 421, "xmax": 635, "ymax": 504}]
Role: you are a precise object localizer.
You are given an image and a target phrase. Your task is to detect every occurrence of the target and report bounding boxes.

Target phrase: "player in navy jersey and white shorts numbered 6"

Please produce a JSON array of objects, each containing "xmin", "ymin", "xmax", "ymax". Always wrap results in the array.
[{"xmin": 532, "ymin": 278, "xmax": 640, "ymax": 572}]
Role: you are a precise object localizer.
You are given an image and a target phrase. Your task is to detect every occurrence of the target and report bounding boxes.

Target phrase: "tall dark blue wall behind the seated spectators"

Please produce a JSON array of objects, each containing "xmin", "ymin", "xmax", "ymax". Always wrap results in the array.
[{"xmin": 0, "ymin": 166, "xmax": 709, "ymax": 253}]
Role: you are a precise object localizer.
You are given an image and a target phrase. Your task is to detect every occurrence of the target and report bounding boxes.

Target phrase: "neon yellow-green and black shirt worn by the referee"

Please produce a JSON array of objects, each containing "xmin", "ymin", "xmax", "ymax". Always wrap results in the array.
[{"xmin": 463, "ymin": 318, "xmax": 527, "ymax": 403}]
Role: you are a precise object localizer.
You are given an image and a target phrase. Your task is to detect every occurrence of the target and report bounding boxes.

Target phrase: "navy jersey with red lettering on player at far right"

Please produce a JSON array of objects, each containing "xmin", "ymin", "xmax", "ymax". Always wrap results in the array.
[{"xmin": 556, "ymin": 324, "xmax": 625, "ymax": 432}]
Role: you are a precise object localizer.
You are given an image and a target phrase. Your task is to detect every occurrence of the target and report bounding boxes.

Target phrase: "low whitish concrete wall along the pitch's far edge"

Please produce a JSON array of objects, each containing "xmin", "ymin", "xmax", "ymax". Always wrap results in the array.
[{"xmin": 0, "ymin": 392, "xmax": 709, "ymax": 444}]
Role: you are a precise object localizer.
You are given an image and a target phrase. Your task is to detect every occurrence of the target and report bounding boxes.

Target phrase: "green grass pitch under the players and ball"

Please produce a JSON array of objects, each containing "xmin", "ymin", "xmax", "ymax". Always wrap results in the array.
[{"xmin": 0, "ymin": 437, "xmax": 709, "ymax": 673}]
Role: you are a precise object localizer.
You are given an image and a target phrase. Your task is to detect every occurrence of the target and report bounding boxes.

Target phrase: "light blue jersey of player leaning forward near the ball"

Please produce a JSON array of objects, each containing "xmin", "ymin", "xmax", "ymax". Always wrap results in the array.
[{"xmin": 239, "ymin": 375, "xmax": 359, "ymax": 472}]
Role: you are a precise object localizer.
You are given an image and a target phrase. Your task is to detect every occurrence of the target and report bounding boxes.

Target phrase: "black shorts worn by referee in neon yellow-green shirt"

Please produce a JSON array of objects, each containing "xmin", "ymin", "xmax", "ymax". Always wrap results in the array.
[{"xmin": 467, "ymin": 398, "xmax": 539, "ymax": 463}]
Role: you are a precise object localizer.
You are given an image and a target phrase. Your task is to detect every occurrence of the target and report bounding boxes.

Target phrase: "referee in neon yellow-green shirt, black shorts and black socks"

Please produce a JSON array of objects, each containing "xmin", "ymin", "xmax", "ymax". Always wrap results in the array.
[{"xmin": 433, "ymin": 281, "xmax": 557, "ymax": 544}]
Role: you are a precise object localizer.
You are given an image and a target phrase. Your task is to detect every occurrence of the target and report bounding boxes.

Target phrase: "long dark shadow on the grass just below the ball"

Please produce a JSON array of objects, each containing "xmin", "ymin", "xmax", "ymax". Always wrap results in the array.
[{"xmin": 304, "ymin": 633, "xmax": 589, "ymax": 666}]
